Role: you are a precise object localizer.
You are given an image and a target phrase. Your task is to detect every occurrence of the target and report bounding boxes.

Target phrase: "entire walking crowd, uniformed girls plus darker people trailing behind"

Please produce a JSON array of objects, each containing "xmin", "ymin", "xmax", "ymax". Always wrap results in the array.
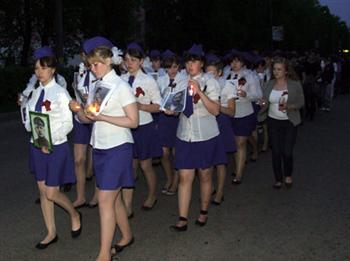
[{"xmin": 18, "ymin": 36, "xmax": 349, "ymax": 261}]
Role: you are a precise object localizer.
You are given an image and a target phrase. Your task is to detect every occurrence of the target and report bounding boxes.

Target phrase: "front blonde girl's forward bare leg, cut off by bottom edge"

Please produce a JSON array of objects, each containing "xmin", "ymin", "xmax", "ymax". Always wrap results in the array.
[{"xmin": 96, "ymin": 190, "xmax": 120, "ymax": 261}]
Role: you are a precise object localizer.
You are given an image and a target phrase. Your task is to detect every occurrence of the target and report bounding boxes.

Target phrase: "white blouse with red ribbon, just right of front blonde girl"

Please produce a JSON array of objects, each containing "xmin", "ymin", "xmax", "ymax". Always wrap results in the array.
[{"xmin": 122, "ymin": 70, "xmax": 162, "ymax": 125}]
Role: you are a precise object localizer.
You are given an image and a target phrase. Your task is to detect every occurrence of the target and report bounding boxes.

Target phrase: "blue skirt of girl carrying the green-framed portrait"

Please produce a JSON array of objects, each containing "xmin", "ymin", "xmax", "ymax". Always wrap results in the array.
[{"xmin": 29, "ymin": 142, "xmax": 76, "ymax": 187}]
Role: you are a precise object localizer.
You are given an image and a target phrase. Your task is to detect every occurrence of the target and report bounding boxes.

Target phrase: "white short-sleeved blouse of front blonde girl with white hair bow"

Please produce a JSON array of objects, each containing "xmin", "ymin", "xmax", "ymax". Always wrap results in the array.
[{"xmin": 90, "ymin": 70, "xmax": 136, "ymax": 149}]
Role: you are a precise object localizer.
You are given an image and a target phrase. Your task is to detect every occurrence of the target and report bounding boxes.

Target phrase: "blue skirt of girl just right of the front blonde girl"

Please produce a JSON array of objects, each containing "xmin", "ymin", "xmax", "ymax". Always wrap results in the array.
[{"xmin": 131, "ymin": 121, "xmax": 163, "ymax": 160}]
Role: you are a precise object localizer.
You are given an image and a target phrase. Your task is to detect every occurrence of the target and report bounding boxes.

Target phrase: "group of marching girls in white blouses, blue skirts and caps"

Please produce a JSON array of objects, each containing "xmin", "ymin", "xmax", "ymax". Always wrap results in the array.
[{"xmin": 21, "ymin": 36, "xmax": 304, "ymax": 261}]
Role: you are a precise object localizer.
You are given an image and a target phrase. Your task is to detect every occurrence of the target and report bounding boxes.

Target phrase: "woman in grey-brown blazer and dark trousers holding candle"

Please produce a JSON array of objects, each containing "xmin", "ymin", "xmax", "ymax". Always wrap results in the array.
[{"xmin": 263, "ymin": 57, "xmax": 304, "ymax": 189}]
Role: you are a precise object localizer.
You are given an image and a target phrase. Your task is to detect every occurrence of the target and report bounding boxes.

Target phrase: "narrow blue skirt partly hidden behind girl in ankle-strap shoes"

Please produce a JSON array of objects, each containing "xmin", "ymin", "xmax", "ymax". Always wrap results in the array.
[{"xmin": 216, "ymin": 113, "xmax": 237, "ymax": 152}]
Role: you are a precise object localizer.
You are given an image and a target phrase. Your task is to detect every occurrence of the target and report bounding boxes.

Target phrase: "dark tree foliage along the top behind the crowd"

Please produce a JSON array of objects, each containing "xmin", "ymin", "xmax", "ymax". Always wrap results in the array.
[{"xmin": 0, "ymin": 0, "xmax": 350, "ymax": 65}]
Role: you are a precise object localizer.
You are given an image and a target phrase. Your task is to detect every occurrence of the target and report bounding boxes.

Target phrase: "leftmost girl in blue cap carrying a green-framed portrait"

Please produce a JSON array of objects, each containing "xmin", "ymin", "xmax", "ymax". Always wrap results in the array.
[{"xmin": 25, "ymin": 47, "xmax": 83, "ymax": 249}]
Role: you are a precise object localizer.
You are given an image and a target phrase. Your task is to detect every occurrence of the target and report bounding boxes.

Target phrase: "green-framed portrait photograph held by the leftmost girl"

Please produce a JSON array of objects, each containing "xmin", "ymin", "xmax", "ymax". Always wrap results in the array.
[{"xmin": 29, "ymin": 111, "xmax": 53, "ymax": 152}]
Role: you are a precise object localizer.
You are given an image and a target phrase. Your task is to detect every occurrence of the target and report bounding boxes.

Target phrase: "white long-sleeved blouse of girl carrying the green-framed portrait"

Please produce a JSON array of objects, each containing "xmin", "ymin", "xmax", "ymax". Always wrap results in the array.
[{"xmin": 25, "ymin": 79, "xmax": 73, "ymax": 145}]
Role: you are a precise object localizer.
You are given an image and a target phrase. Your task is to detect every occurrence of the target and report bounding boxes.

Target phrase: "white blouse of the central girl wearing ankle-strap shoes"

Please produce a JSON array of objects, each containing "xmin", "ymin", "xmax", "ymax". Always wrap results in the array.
[{"xmin": 176, "ymin": 74, "xmax": 220, "ymax": 142}]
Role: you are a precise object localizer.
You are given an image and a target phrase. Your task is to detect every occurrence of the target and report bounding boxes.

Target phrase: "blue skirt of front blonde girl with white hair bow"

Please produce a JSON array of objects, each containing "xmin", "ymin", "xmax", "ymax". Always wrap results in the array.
[{"xmin": 92, "ymin": 143, "xmax": 134, "ymax": 190}]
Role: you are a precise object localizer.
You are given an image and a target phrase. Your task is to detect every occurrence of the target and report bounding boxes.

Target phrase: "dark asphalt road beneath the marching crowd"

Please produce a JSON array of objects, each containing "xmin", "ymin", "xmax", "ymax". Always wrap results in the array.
[{"xmin": 0, "ymin": 96, "xmax": 350, "ymax": 261}]
